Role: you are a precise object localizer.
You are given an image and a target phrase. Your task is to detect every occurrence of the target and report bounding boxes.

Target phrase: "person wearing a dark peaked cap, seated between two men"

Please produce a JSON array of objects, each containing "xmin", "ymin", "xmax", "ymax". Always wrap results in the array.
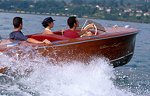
[{"xmin": 42, "ymin": 17, "xmax": 55, "ymax": 34}]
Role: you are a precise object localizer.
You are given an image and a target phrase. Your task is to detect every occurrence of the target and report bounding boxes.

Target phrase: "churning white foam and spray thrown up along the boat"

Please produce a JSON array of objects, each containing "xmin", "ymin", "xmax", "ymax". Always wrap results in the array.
[{"xmin": 0, "ymin": 54, "xmax": 138, "ymax": 96}]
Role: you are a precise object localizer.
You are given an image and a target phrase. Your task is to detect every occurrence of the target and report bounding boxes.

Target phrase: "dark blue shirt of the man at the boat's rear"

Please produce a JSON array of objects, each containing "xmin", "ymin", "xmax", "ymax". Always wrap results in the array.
[{"xmin": 9, "ymin": 31, "xmax": 28, "ymax": 41}]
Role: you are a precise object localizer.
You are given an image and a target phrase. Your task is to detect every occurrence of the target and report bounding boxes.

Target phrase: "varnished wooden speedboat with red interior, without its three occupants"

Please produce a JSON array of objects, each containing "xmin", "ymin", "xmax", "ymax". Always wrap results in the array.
[{"xmin": 0, "ymin": 22, "xmax": 138, "ymax": 73}]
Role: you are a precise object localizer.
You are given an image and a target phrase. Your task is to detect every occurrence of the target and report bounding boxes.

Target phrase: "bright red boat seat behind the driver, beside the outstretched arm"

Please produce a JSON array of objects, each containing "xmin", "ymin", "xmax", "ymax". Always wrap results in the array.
[{"xmin": 27, "ymin": 34, "xmax": 69, "ymax": 42}]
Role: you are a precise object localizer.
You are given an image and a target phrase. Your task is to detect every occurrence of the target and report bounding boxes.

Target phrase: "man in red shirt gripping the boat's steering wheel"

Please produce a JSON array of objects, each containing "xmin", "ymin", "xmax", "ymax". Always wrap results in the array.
[{"xmin": 63, "ymin": 16, "xmax": 94, "ymax": 38}]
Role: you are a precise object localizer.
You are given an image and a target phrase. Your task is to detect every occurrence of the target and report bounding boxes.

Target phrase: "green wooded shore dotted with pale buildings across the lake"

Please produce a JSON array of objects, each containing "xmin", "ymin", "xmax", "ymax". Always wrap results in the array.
[{"xmin": 0, "ymin": 0, "xmax": 150, "ymax": 23}]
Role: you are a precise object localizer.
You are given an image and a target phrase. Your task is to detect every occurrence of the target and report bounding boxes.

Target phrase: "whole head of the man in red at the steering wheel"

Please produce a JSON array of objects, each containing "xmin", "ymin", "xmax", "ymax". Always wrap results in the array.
[{"xmin": 67, "ymin": 16, "xmax": 79, "ymax": 28}]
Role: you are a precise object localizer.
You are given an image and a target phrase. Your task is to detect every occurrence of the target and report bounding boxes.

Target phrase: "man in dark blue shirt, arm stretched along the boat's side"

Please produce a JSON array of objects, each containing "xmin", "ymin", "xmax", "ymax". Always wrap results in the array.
[{"xmin": 9, "ymin": 17, "xmax": 51, "ymax": 44}]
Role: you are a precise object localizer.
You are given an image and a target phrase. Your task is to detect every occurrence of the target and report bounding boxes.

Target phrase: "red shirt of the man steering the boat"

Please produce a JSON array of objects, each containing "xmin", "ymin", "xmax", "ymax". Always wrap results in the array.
[{"xmin": 64, "ymin": 29, "xmax": 80, "ymax": 38}]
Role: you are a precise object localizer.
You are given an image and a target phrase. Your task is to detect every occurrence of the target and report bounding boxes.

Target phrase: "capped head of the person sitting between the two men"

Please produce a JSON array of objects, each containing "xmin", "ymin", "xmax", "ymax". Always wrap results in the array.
[{"xmin": 42, "ymin": 17, "xmax": 55, "ymax": 28}]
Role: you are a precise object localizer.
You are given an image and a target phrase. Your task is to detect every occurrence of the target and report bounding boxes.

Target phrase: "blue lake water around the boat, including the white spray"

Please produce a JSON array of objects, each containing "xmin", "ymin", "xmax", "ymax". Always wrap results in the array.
[{"xmin": 0, "ymin": 13, "xmax": 150, "ymax": 96}]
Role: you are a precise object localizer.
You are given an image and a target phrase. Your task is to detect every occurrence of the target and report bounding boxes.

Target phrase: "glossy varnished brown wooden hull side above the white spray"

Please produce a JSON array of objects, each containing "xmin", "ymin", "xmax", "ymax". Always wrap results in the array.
[{"xmin": 34, "ymin": 34, "xmax": 136, "ymax": 67}]
